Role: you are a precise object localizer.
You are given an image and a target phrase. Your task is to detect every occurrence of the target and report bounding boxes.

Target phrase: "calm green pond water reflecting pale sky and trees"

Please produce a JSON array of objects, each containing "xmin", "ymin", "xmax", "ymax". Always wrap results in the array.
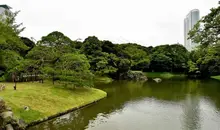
[{"xmin": 29, "ymin": 79, "xmax": 220, "ymax": 130}]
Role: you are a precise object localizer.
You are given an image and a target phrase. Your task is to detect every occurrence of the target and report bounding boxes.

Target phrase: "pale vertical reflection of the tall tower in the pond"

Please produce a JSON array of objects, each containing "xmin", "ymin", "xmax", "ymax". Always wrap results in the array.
[{"xmin": 182, "ymin": 95, "xmax": 201, "ymax": 130}]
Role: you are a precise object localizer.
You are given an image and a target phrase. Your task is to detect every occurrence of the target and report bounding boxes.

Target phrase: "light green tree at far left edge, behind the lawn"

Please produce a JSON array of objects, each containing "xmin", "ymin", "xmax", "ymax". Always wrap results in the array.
[{"xmin": 0, "ymin": 21, "xmax": 28, "ymax": 80}]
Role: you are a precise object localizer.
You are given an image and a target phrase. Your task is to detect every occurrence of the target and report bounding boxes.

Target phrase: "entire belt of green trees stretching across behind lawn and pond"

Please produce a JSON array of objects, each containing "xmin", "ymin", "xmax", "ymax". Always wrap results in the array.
[{"xmin": 0, "ymin": 4, "xmax": 220, "ymax": 86}]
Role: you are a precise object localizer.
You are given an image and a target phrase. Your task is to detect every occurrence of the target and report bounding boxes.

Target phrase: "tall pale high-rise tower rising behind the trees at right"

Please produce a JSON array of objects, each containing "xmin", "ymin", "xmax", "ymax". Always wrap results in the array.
[{"xmin": 184, "ymin": 9, "xmax": 200, "ymax": 51}]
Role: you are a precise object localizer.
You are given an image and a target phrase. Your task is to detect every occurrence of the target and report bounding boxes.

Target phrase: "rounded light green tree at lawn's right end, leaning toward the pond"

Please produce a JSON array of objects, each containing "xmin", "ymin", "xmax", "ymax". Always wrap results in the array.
[{"xmin": 55, "ymin": 53, "xmax": 93, "ymax": 87}]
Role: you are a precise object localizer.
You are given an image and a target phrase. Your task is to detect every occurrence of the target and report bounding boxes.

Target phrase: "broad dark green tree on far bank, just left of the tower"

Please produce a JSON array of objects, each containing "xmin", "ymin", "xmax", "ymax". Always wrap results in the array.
[{"xmin": 150, "ymin": 44, "xmax": 189, "ymax": 73}]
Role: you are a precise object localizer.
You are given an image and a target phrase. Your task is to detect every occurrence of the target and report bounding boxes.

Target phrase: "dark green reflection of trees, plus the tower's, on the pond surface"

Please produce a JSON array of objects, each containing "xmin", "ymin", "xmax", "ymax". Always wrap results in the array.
[{"xmin": 27, "ymin": 80, "xmax": 220, "ymax": 130}]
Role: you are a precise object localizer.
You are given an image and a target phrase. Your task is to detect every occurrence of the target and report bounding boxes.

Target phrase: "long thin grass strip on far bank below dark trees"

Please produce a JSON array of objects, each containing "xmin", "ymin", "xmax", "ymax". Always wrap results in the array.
[{"xmin": 146, "ymin": 72, "xmax": 186, "ymax": 79}]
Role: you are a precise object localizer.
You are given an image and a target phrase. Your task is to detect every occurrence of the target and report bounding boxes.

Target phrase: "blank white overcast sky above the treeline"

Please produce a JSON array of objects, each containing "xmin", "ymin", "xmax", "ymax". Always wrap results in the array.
[{"xmin": 0, "ymin": 0, "xmax": 218, "ymax": 46}]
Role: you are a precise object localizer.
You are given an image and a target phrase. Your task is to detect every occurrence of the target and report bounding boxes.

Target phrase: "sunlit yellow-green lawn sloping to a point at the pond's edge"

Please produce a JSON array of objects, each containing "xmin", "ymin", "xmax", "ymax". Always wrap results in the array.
[{"xmin": 0, "ymin": 82, "xmax": 107, "ymax": 123}]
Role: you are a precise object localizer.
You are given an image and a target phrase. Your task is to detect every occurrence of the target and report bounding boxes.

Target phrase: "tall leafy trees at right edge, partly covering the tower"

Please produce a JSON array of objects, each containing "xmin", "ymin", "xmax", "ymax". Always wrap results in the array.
[{"xmin": 189, "ymin": 6, "xmax": 220, "ymax": 77}]
